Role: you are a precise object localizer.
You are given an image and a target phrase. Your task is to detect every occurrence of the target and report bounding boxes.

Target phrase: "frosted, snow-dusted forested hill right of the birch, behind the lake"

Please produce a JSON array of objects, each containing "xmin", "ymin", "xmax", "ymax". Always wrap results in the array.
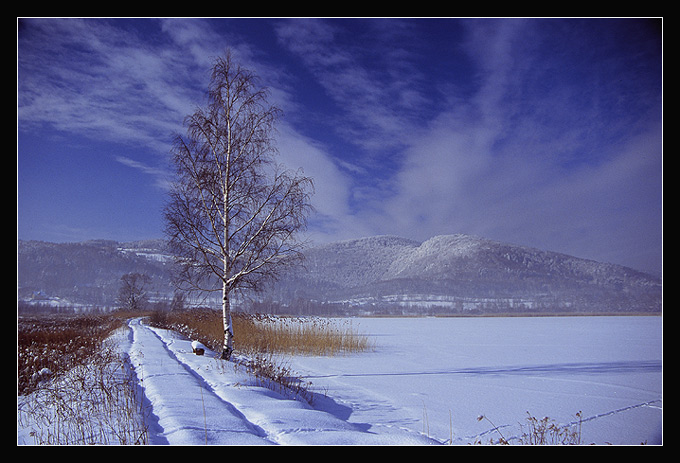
[{"xmin": 272, "ymin": 235, "xmax": 661, "ymax": 312}]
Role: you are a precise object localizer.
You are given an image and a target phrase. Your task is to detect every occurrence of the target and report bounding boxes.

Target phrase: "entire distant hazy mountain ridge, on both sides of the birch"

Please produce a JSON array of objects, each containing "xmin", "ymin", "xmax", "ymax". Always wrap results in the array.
[{"xmin": 17, "ymin": 234, "xmax": 662, "ymax": 313}]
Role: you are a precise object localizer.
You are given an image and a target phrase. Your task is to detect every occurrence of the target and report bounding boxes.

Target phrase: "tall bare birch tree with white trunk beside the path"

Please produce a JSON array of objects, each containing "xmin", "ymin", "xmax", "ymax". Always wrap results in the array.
[{"xmin": 165, "ymin": 52, "xmax": 313, "ymax": 359}]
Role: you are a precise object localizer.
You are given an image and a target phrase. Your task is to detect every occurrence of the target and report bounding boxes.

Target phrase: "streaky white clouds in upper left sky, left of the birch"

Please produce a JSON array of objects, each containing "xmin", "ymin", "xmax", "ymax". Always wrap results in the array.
[{"xmin": 18, "ymin": 19, "xmax": 212, "ymax": 153}]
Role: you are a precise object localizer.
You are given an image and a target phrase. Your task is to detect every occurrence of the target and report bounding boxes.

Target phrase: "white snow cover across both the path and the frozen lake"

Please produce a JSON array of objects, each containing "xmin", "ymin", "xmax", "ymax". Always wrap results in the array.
[{"xmin": 17, "ymin": 317, "xmax": 662, "ymax": 445}]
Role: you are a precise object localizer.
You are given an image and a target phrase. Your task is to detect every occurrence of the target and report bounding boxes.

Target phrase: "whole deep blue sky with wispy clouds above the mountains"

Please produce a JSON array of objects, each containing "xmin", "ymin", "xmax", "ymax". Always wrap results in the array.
[{"xmin": 17, "ymin": 18, "xmax": 663, "ymax": 273}]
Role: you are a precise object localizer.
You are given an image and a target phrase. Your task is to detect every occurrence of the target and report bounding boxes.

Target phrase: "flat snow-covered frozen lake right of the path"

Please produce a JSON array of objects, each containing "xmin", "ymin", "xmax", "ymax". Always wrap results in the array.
[{"xmin": 289, "ymin": 316, "xmax": 663, "ymax": 445}]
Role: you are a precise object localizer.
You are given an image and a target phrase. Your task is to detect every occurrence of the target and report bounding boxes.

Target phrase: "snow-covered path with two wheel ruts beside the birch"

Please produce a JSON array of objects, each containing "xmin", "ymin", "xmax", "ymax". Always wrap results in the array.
[{"xmin": 127, "ymin": 319, "xmax": 437, "ymax": 445}]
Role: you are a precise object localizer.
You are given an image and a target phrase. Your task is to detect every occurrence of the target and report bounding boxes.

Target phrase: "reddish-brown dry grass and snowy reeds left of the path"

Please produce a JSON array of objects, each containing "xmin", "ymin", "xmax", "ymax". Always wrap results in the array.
[{"xmin": 17, "ymin": 314, "xmax": 148, "ymax": 445}]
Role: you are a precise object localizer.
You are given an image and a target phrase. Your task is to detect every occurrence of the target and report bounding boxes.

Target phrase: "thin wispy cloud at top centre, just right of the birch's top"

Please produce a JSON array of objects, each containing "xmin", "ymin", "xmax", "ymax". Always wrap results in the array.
[{"xmin": 276, "ymin": 19, "xmax": 426, "ymax": 152}]
